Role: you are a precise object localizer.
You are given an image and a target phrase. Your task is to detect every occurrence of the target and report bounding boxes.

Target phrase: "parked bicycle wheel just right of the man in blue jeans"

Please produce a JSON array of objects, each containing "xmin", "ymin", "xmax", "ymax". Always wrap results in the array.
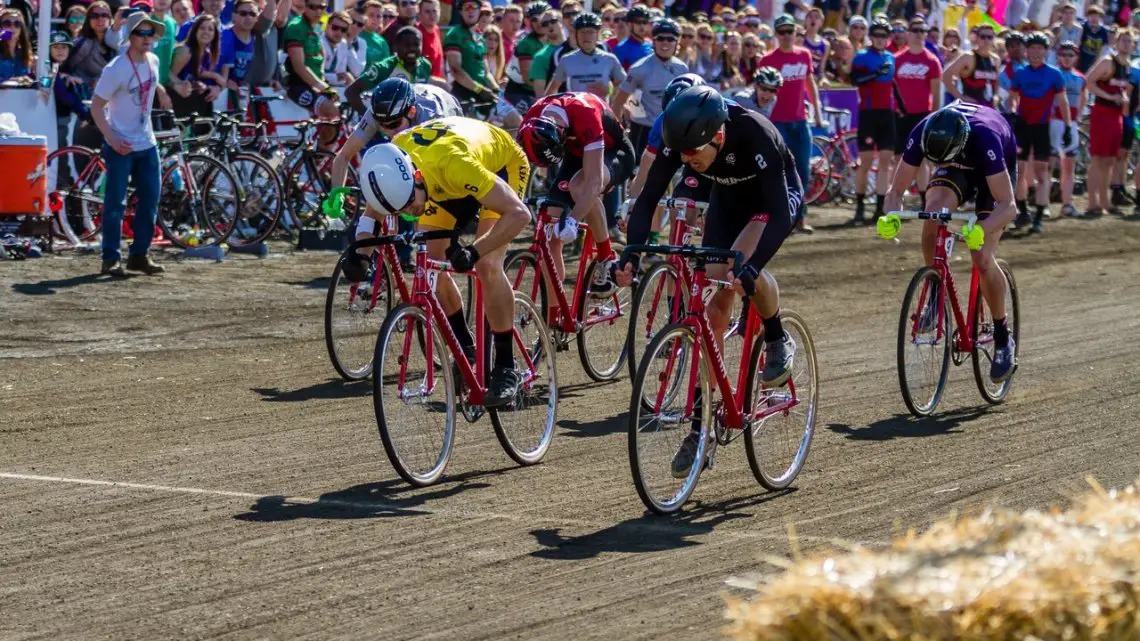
[{"xmin": 157, "ymin": 154, "xmax": 242, "ymax": 249}]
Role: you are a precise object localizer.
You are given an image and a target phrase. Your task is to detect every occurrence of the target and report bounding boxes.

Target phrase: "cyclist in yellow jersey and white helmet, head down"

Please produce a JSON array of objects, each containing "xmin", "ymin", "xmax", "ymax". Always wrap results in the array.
[{"xmin": 360, "ymin": 116, "xmax": 530, "ymax": 408}]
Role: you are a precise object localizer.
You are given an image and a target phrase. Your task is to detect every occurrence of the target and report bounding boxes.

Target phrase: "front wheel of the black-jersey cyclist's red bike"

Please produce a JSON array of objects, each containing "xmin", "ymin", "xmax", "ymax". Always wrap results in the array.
[{"xmin": 628, "ymin": 324, "xmax": 713, "ymax": 514}]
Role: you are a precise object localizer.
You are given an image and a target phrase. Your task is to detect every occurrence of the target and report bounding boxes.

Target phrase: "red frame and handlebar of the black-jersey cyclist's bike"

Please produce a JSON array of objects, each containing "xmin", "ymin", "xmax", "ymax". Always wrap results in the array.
[{"xmin": 627, "ymin": 245, "xmax": 799, "ymax": 430}]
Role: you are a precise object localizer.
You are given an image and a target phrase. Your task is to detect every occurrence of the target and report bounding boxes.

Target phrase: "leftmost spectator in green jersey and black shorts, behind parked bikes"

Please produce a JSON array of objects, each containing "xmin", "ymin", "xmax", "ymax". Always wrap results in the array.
[{"xmin": 282, "ymin": 0, "xmax": 340, "ymax": 148}]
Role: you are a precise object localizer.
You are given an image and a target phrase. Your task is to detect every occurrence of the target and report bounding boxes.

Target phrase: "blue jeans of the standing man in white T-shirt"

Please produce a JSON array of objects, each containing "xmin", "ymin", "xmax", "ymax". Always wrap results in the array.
[{"xmin": 103, "ymin": 144, "xmax": 161, "ymax": 260}]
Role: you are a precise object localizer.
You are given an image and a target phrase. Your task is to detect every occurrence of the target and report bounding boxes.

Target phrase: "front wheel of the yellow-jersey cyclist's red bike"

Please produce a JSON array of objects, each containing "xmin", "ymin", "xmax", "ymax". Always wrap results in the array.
[{"xmin": 372, "ymin": 303, "xmax": 456, "ymax": 487}]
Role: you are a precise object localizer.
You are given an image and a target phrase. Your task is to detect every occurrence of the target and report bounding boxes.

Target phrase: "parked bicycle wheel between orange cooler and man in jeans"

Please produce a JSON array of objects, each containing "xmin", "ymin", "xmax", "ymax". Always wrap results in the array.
[{"xmin": 46, "ymin": 145, "xmax": 107, "ymax": 245}]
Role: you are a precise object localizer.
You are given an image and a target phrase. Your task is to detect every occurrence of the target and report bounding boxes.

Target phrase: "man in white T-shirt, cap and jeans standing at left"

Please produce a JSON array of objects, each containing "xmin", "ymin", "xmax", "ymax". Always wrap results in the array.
[{"xmin": 91, "ymin": 13, "xmax": 171, "ymax": 278}]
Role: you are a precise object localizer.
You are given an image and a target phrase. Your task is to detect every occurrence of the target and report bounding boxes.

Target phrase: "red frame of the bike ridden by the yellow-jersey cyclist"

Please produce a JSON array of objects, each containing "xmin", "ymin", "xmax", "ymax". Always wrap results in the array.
[{"xmin": 389, "ymin": 232, "xmax": 549, "ymax": 405}]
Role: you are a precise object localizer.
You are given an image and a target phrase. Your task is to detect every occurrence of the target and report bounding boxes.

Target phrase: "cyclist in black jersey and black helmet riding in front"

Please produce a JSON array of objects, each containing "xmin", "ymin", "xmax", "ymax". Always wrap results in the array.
[{"xmin": 614, "ymin": 86, "xmax": 804, "ymax": 478}]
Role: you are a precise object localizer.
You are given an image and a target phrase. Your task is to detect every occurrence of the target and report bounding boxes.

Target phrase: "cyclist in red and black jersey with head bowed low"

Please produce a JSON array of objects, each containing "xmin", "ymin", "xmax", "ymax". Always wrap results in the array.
[{"xmin": 519, "ymin": 92, "xmax": 635, "ymax": 297}]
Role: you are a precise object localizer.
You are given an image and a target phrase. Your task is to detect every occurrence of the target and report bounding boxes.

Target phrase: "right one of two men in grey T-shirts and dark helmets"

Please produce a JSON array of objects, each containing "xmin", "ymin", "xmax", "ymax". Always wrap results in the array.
[{"xmin": 613, "ymin": 19, "xmax": 689, "ymax": 157}]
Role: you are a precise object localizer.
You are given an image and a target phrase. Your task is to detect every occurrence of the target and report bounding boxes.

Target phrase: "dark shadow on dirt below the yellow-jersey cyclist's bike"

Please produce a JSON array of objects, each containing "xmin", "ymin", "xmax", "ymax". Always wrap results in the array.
[{"xmin": 234, "ymin": 466, "xmax": 516, "ymax": 522}]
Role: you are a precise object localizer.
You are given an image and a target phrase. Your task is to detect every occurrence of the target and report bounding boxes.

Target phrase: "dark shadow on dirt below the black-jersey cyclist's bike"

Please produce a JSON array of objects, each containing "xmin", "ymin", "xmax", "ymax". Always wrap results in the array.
[{"xmin": 530, "ymin": 488, "xmax": 796, "ymax": 561}]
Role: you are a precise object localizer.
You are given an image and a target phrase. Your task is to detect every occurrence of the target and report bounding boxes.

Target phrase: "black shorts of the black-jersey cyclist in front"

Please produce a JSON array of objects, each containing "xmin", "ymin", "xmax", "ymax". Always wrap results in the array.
[{"xmin": 701, "ymin": 163, "xmax": 804, "ymax": 269}]
